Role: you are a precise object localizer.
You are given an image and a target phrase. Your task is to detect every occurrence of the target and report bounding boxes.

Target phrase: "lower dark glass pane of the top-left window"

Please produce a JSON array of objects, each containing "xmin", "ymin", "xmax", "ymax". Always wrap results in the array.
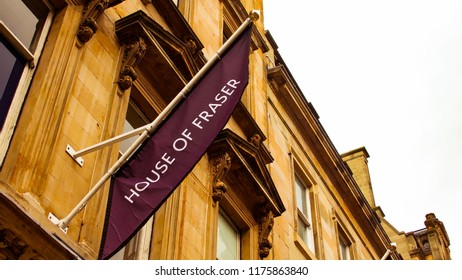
[{"xmin": 0, "ymin": 36, "xmax": 26, "ymax": 129}]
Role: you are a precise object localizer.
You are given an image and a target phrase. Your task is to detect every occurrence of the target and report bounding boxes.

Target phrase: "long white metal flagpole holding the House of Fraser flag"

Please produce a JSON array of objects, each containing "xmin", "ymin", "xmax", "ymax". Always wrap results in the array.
[{"xmin": 48, "ymin": 10, "xmax": 259, "ymax": 232}]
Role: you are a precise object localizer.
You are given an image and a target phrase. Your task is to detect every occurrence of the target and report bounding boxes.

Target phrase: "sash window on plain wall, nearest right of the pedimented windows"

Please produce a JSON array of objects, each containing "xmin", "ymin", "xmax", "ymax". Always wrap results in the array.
[{"xmin": 295, "ymin": 175, "xmax": 315, "ymax": 252}]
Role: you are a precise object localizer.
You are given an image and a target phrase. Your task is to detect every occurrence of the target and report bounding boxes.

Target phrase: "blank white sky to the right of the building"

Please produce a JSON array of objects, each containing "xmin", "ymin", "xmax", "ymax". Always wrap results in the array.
[{"xmin": 264, "ymin": 0, "xmax": 462, "ymax": 260}]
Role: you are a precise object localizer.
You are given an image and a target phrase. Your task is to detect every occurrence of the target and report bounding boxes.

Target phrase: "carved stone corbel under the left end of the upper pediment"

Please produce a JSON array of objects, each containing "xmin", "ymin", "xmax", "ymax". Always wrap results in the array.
[{"xmin": 117, "ymin": 37, "xmax": 146, "ymax": 91}]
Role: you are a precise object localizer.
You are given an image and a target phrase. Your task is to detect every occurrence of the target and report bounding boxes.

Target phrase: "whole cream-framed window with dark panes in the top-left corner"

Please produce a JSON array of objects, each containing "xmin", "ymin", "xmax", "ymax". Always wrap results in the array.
[{"xmin": 0, "ymin": 0, "xmax": 52, "ymax": 158}]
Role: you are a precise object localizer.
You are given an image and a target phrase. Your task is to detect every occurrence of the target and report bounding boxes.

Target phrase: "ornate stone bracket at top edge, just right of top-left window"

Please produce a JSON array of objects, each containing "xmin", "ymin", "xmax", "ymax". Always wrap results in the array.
[{"xmin": 77, "ymin": 0, "xmax": 125, "ymax": 44}]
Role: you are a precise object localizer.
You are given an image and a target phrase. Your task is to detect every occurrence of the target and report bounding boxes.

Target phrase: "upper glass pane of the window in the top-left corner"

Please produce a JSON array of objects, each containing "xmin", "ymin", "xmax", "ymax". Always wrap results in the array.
[{"xmin": 0, "ymin": 0, "xmax": 49, "ymax": 52}]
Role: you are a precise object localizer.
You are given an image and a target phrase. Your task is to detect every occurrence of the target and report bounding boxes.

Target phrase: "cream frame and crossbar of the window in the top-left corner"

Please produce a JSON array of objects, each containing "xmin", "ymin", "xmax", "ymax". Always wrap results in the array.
[{"xmin": 0, "ymin": 0, "xmax": 55, "ymax": 167}]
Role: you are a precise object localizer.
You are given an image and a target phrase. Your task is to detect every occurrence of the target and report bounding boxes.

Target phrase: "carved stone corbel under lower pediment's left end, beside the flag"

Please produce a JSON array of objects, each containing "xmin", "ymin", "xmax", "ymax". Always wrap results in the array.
[{"xmin": 212, "ymin": 153, "xmax": 231, "ymax": 202}]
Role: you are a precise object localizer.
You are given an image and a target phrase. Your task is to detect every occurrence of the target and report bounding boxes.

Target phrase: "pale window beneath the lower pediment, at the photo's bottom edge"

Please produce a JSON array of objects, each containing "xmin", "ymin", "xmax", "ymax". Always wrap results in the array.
[{"xmin": 217, "ymin": 212, "xmax": 241, "ymax": 260}]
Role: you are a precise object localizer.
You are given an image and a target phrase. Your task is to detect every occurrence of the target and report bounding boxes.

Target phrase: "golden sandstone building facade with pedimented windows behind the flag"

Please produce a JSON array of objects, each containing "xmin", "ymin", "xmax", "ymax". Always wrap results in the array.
[{"xmin": 0, "ymin": 0, "xmax": 448, "ymax": 260}]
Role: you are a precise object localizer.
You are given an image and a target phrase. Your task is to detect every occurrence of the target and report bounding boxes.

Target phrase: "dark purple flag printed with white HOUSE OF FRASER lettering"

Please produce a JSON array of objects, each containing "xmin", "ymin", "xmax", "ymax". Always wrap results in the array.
[{"xmin": 99, "ymin": 24, "xmax": 252, "ymax": 259}]
